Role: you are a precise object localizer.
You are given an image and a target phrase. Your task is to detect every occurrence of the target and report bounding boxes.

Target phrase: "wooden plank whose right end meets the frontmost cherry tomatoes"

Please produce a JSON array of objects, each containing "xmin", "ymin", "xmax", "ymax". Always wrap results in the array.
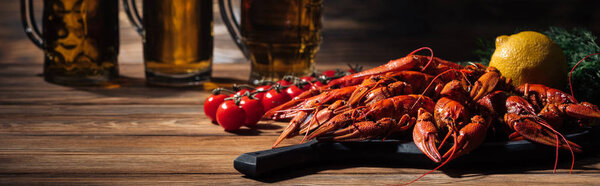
[{"xmin": 0, "ymin": 105, "xmax": 287, "ymax": 136}]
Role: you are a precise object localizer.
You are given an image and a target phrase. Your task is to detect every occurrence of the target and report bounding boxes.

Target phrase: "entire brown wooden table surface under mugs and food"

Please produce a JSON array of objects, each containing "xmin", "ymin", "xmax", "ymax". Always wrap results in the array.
[{"xmin": 0, "ymin": 63, "xmax": 600, "ymax": 185}]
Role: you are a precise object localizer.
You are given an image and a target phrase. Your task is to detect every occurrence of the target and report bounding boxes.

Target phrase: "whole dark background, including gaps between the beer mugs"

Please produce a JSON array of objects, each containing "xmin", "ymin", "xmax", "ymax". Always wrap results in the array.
[{"xmin": 0, "ymin": 0, "xmax": 600, "ymax": 64}]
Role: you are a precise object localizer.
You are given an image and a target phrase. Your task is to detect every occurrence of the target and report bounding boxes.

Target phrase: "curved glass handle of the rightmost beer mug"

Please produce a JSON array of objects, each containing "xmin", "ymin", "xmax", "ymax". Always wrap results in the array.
[{"xmin": 219, "ymin": 0, "xmax": 250, "ymax": 59}]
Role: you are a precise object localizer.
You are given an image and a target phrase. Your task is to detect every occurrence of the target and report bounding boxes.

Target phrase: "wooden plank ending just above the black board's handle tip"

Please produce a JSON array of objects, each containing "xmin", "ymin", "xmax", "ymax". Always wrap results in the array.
[{"xmin": 0, "ymin": 135, "xmax": 301, "ymax": 154}]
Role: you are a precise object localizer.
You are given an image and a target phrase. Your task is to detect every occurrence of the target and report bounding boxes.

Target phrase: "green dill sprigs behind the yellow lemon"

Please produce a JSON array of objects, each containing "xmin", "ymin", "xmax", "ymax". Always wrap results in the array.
[{"xmin": 474, "ymin": 27, "xmax": 600, "ymax": 105}]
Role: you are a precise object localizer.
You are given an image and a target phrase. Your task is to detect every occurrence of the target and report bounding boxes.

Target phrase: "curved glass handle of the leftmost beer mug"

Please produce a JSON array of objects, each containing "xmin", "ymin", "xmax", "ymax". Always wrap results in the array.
[{"xmin": 21, "ymin": 0, "xmax": 44, "ymax": 48}]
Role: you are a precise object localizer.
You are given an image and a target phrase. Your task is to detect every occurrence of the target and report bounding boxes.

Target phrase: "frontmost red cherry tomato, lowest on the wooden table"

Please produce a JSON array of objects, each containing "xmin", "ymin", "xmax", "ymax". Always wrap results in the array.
[{"xmin": 217, "ymin": 100, "xmax": 246, "ymax": 131}]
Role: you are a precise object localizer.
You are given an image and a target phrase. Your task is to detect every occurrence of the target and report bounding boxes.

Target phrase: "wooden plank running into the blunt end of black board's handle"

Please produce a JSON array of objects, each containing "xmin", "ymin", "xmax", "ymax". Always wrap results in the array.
[{"xmin": 0, "ymin": 154, "xmax": 237, "ymax": 174}]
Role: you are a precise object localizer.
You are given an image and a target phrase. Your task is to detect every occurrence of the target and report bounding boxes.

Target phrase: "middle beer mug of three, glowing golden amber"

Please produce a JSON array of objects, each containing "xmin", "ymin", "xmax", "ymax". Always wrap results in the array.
[{"xmin": 123, "ymin": 0, "xmax": 213, "ymax": 86}]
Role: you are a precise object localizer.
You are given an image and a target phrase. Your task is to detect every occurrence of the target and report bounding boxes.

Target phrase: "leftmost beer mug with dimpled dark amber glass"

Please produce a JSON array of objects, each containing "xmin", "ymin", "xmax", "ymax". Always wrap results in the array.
[{"xmin": 21, "ymin": 0, "xmax": 119, "ymax": 85}]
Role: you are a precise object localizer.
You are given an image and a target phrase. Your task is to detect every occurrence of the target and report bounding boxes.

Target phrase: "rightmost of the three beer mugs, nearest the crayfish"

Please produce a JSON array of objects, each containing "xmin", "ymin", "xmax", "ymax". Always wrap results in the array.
[{"xmin": 219, "ymin": 0, "xmax": 322, "ymax": 81}]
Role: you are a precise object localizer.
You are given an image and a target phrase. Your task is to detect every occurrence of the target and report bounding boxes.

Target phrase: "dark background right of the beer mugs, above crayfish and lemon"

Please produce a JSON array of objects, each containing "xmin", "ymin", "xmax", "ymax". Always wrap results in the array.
[{"xmin": 322, "ymin": 0, "xmax": 600, "ymax": 61}]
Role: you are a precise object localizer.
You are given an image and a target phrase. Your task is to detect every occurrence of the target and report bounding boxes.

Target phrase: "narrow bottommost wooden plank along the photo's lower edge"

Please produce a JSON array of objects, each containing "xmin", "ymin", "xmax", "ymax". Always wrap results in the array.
[{"xmin": 0, "ymin": 172, "xmax": 600, "ymax": 185}]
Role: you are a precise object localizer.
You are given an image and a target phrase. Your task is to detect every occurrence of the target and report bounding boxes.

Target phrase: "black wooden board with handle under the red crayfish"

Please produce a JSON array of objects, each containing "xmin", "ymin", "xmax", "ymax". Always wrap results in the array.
[{"xmin": 233, "ymin": 127, "xmax": 600, "ymax": 178}]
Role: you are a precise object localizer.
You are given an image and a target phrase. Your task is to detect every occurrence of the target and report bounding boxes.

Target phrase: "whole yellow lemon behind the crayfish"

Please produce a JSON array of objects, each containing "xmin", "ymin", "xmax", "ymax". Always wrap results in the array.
[{"xmin": 490, "ymin": 31, "xmax": 567, "ymax": 89}]
